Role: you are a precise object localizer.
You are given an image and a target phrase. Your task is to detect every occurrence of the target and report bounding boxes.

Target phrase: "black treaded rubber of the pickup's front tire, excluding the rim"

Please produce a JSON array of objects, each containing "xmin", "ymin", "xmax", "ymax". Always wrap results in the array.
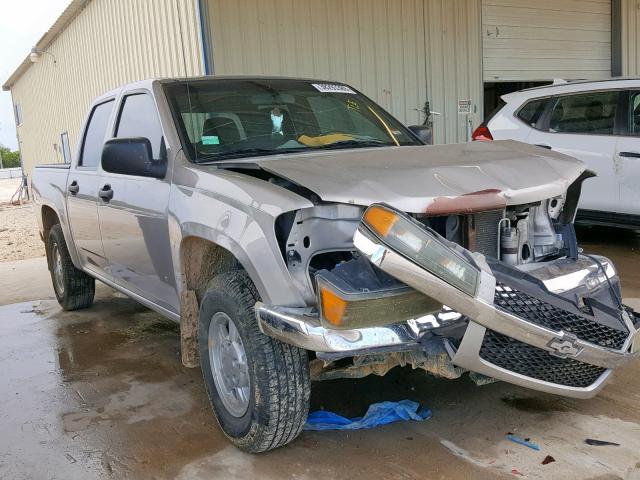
[{"xmin": 198, "ymin": 270, "xmax": 311, "ymax": 453}]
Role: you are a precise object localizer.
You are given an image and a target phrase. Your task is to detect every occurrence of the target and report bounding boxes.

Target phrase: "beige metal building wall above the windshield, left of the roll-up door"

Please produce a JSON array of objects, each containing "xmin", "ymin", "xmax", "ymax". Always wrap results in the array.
[{"xmin": 206, "ymin": 0, "xmax": 482, "ymax": 143}]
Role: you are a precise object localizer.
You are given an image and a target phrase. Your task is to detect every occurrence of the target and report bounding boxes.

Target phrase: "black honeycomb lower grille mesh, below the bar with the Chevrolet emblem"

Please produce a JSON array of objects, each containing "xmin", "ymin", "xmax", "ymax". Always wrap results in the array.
[{"xmin": 480, "ymin": 330, "xmax": 606, "ymax": 388}]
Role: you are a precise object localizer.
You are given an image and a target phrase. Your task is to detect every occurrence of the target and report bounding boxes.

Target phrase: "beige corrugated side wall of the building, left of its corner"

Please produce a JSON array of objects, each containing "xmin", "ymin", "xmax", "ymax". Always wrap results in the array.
[{"xmin": 11, "ymin": 0, "xmax": 203, "ymax": 173}]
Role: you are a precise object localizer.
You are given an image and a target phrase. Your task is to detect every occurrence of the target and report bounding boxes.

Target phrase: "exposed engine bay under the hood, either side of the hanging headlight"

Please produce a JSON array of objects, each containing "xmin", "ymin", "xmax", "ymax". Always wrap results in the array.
[{"xmin": 276, "ymin": 198, "xmax": 575, "ymax": 306}]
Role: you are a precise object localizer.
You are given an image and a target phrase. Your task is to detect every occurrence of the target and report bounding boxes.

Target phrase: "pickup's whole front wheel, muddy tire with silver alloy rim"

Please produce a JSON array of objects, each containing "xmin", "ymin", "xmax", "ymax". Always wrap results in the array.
[{"xmin": 198, "ymin": 271, "xmax": 311, "ymax": 453}]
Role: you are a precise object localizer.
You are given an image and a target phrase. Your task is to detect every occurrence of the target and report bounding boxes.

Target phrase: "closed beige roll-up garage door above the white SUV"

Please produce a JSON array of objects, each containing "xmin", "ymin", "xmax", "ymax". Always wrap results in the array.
[{"xmin": 482, "ymin": 0, "xmax": 611, "ymax": 82}]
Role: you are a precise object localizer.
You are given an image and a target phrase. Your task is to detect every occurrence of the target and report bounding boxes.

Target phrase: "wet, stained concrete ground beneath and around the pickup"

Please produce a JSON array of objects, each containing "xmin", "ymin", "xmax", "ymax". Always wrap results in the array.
[{"xmin": 0, "ymin": 229, "xmax": 640, "ymax": 479}]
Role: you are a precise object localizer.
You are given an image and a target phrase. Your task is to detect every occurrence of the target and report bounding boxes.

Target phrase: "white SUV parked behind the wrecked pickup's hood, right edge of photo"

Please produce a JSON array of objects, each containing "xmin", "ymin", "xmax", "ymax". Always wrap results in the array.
[{"xmin": 473, "ymin": 79, "xmax": 640, "ymax": 227}]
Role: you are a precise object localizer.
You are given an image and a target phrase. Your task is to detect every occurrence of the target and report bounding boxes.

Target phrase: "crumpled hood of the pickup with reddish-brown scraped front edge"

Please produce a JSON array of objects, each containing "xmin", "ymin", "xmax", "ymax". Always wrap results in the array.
[{"xmin": 253, "ymin": 140, "xmax": 586, "ymax": 214}]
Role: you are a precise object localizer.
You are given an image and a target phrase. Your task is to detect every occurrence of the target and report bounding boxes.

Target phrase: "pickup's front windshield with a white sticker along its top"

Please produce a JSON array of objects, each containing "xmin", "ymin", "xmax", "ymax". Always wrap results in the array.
[{"xmin": 165, "ymin": 79, "xmax": 419, "ymax": 163}]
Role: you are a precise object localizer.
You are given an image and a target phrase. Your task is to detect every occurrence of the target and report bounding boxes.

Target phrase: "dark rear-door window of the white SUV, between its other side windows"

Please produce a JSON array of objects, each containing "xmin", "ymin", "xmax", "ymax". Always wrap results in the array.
[{"xmin": 549, "ymin": 92, "xmax": 618, "ymax": 135}]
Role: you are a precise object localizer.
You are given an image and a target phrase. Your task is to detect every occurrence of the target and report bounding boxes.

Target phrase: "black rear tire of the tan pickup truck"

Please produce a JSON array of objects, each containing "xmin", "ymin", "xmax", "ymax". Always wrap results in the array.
[{"xmin": 46, "ymin": 224, "xmax": 96, "ymax": 310}]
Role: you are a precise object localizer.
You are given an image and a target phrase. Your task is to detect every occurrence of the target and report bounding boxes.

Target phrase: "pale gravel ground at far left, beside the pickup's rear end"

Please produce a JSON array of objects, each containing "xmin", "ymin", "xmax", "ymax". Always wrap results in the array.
[{"xmin": 0, "ymin": 204, "xmax": 44, "ymax": 262}]
